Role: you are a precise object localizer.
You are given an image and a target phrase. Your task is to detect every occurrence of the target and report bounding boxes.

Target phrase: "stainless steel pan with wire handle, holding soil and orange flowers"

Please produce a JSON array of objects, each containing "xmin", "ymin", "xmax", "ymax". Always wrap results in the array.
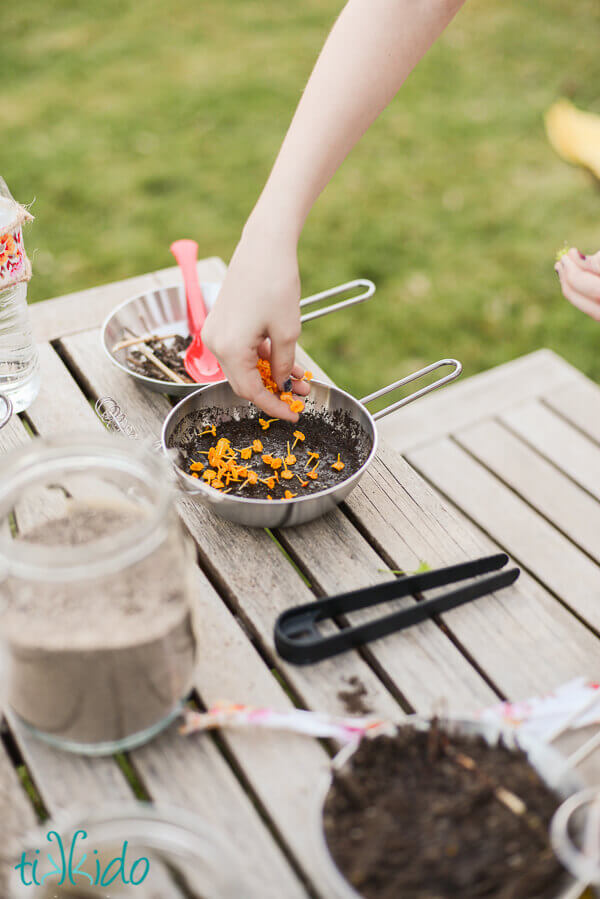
[{"xmin": 161, "ymin": 359, "xmax": 462, "ymax": 528}]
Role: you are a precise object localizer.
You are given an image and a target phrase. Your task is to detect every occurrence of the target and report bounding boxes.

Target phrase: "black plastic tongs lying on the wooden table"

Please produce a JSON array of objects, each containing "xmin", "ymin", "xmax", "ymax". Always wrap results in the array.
[{"xmin": 275, "ymin": 553, "xmax": 520, "ymax": 665}]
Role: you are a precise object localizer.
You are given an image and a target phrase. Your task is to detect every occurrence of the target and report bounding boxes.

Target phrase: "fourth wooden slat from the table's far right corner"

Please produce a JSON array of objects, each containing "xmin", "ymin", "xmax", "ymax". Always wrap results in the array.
[{"xmin": 410, "ymin": 439, "xmax": 600, "ymax": 632}]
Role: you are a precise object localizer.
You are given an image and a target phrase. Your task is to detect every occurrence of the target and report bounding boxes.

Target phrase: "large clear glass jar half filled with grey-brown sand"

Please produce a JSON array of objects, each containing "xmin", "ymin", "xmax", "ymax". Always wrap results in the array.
[{"xmin": 0, "ymin": 434, "xmax": 197, "ymax": 755}]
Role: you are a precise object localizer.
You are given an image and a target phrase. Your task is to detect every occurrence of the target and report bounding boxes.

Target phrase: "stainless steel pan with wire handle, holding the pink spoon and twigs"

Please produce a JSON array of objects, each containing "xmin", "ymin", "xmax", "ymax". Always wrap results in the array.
[{"xmin": 101, "ymin": 278, "xmax": 375, "ymax": 396}]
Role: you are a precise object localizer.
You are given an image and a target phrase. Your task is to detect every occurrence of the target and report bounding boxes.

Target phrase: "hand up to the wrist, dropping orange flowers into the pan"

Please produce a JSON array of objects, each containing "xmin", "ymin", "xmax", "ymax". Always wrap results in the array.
[{"xmin": 202, "ymin": 224, "xmax": 310, "ymax": 422}]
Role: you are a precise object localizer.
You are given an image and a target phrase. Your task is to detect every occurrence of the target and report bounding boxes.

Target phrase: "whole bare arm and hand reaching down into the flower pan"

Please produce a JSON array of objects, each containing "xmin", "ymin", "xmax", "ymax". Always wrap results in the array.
[{"xmin": 202, "ymin": 0, "xmax": 464, "ymax": 420}]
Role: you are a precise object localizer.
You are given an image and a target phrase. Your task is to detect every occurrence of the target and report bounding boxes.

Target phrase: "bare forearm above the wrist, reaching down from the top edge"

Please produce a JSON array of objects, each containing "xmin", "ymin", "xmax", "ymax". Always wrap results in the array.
[{"xmin": 251, "ymin": 0, "xmax": 465, "ymax": 237}]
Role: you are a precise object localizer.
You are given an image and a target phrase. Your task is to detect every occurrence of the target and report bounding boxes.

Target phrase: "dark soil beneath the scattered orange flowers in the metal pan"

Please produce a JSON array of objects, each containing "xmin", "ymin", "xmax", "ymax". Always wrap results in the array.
[{"xmin": 170, "ymin": 407, "xmax": 371, "ymax": 500}]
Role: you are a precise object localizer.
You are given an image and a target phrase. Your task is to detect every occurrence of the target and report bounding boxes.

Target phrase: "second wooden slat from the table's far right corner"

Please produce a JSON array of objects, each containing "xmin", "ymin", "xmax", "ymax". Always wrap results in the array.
[{"xmin": 501, "ymin": 402, "xmax": 600, "ymax": 499}]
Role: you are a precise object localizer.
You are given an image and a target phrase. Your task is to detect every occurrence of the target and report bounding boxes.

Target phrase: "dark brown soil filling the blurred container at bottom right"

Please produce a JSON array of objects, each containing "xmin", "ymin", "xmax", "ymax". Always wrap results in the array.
[{"xmin": 324, "ymin": 722, "xmax": 563, "ymax": 899}]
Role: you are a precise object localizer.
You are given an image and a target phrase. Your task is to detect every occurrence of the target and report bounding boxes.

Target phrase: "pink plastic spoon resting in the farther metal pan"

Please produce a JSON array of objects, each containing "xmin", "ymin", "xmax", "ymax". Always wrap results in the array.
[{"xmin": 171, "ymin": 240, "xmax": 225, "ymax": 384}]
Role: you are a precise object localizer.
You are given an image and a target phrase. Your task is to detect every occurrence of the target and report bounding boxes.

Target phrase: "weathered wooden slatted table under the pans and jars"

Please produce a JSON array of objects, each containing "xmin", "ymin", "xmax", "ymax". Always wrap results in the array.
[{"xmin": 0, "ymin": 259, "xmax": 600, "ymax": 899}]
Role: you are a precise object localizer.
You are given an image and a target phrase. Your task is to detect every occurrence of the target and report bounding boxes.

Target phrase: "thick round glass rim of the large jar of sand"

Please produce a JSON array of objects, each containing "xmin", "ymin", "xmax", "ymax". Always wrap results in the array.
[{"xmin": 0, "ymin": 432, "xmax": 172, "ymax": 581}]
